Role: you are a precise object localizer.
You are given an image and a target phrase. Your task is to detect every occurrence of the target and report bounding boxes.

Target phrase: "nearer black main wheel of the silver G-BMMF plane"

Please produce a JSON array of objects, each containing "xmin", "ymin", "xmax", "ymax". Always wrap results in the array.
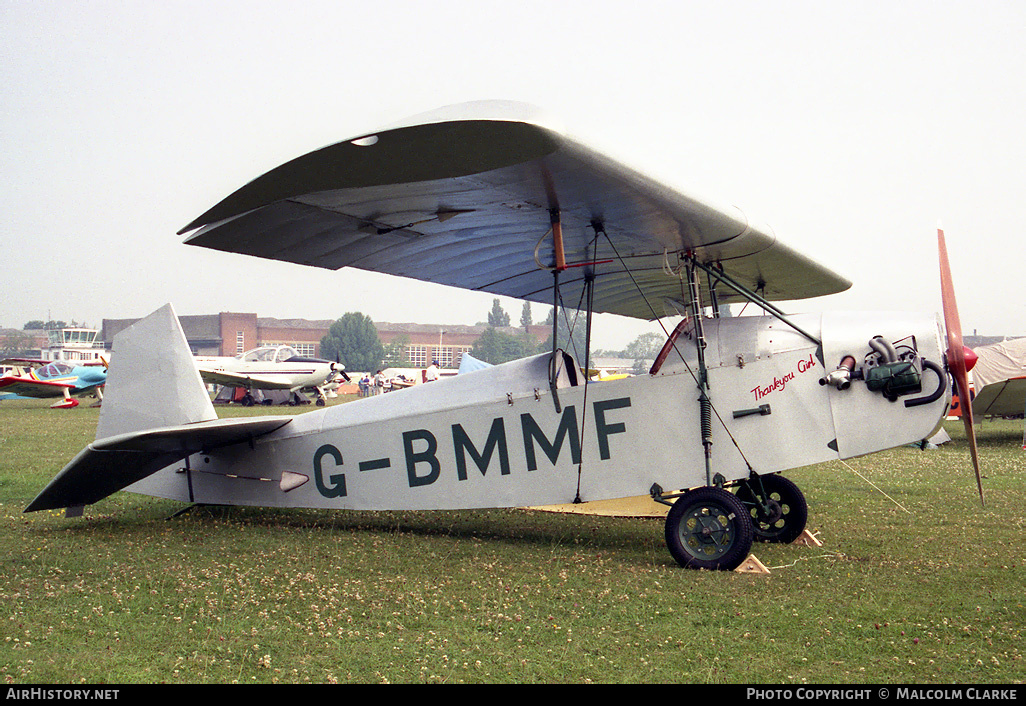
[{"xmin": 666, "ymin": 486, "xmax": 753, "ymax": 571}]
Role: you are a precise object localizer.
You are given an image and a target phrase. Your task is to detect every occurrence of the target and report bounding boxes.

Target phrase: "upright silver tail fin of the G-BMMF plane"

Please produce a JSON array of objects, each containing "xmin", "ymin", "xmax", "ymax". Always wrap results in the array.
[{"xmin": 96, "ymin": 304, "xmax": 218, "ymax": 440}]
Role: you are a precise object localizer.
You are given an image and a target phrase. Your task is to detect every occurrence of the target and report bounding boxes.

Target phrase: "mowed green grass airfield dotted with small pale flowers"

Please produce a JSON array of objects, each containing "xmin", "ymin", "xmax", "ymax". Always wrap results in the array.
[{"xmin": 0, "ymin": 400, "xmax": 1026, "ymax": 684}]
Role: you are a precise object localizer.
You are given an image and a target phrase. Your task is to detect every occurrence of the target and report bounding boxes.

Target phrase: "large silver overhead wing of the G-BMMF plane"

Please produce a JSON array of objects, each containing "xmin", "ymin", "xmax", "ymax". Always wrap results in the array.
[{"xmin": 181, "ymin": 102, "xmax": 851, "ymax": 319}]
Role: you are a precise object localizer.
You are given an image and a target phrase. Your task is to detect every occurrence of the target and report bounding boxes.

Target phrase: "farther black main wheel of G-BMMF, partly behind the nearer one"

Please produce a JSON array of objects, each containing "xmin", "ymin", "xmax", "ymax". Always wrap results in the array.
[{"xmin": 738, "ymin": 474, "xmax": 808, "ymax": 544}]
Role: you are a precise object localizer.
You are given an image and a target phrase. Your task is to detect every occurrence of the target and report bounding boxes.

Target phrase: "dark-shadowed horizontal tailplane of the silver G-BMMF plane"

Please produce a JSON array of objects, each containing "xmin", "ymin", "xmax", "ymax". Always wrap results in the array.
[{"xmin": 25, "ymin": 417, "xmax": 292, "ymax": 512}]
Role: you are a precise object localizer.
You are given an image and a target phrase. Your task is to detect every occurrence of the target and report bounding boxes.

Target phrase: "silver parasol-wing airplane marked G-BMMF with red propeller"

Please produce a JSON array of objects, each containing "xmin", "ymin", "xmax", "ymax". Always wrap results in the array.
[{"xmin": 27, "ymin": 102, "xmax": 982, "ymax": 570}]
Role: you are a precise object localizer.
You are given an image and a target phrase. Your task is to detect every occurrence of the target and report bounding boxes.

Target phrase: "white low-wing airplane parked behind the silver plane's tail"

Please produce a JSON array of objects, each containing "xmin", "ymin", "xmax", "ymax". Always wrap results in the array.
[{"xmin": 196, "ymin": 346, "xmax": 349, "ymax": 406}]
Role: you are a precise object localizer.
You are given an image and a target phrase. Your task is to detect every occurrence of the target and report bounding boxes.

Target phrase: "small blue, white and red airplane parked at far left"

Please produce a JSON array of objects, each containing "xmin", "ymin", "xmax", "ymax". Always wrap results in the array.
[{"xmin": 0, "ymin": 358, "xmax": 107, "ymax": 409}]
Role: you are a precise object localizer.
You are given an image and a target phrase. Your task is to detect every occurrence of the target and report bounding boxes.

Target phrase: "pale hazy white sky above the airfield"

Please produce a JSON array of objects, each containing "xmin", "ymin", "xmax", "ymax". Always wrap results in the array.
[{"xmin": 0, "ymin": 0, "xmax": 1026, "ymax": 349}]
